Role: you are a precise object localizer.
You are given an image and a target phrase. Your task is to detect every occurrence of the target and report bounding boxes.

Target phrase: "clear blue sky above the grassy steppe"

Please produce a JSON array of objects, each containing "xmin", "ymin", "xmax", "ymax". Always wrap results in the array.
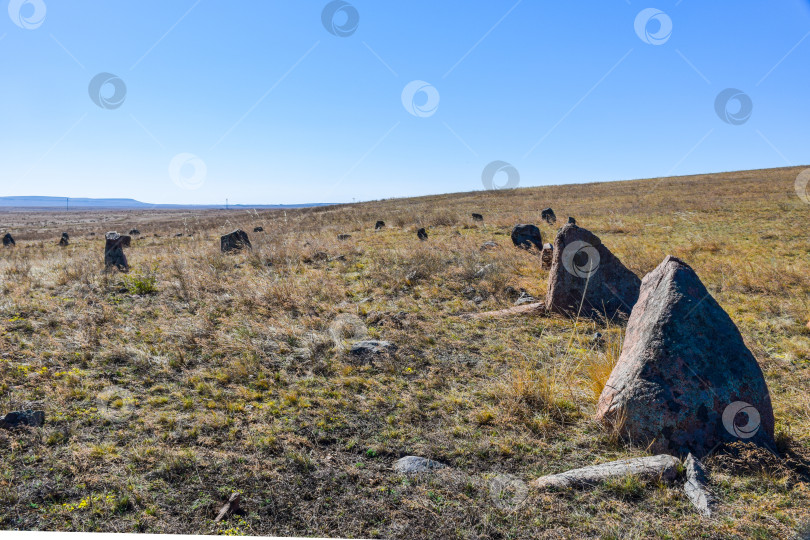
[{"xmin": 0, "ymin": 0, "xmax": 810, "ymax": 204}]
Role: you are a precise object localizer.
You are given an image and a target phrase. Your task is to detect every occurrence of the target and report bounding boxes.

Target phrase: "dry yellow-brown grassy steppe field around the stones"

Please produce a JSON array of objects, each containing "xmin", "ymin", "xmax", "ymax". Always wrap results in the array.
[{"xmin": 0, "ymin": 168, "xmax": 810, "ymax": 538}]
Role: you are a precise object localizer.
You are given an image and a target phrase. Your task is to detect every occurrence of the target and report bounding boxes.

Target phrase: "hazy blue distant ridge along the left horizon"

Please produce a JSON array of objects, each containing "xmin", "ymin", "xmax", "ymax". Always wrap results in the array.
[{"xmin": 0, "ymin": 196, "xmax": 331, "ymax": 210}]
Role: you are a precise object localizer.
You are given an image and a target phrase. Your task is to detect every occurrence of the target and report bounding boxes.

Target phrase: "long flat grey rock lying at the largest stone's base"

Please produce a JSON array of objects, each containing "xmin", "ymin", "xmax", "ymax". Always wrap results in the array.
[{"xmin": 533, "ymin": 454, "xmax": 681, "ymax": 489}]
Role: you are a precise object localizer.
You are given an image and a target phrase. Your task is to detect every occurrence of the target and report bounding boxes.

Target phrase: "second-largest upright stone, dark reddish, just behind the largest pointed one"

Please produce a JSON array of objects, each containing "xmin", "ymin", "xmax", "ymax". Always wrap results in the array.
[{"xmin": 546, "ymin": 223, "xmax": 641, "ymax": 319}]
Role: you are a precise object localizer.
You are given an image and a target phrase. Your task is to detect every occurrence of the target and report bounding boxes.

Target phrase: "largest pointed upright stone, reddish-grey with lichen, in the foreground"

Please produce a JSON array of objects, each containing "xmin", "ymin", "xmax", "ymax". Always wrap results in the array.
[{"xmin": 597, "ymin": 256, "xmax": 774, "ymax": 458}]
